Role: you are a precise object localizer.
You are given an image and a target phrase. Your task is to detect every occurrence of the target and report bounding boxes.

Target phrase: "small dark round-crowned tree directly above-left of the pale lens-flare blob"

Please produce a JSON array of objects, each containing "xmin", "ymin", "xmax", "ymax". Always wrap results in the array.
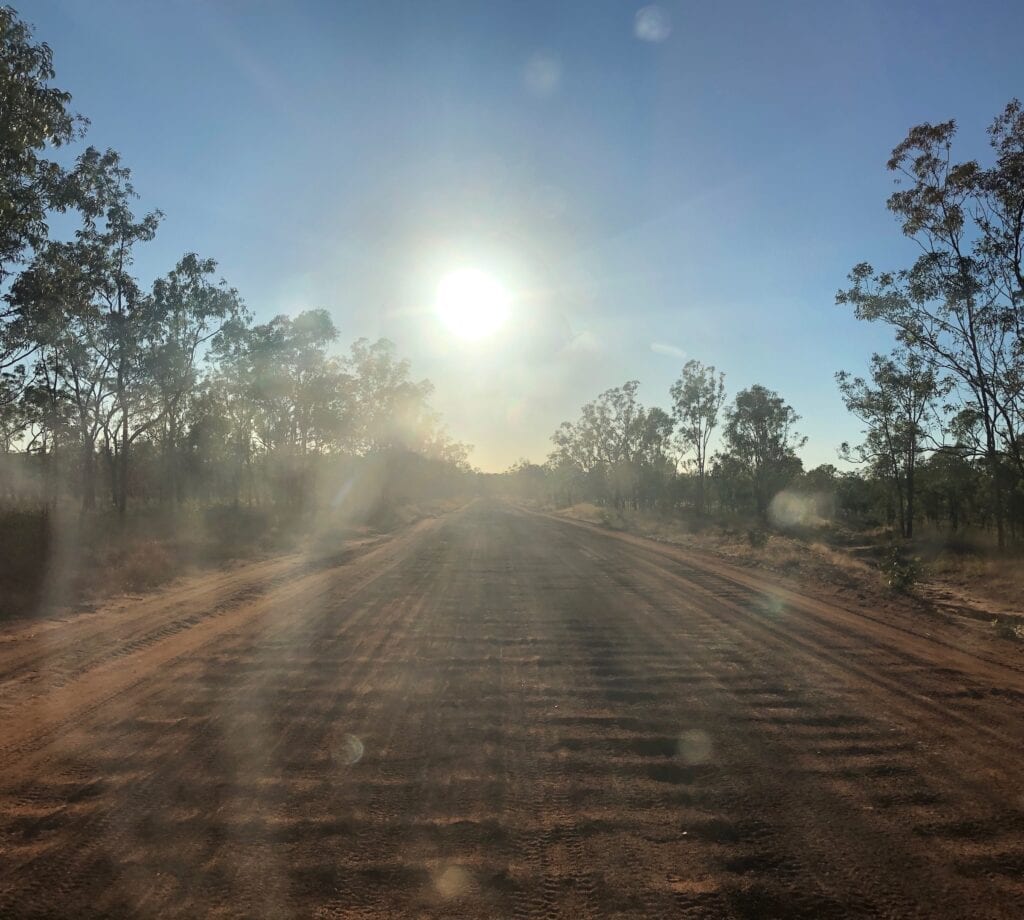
[{"xmin": 725, "ymin": 383, "xmax": 807, "ymax": 516}]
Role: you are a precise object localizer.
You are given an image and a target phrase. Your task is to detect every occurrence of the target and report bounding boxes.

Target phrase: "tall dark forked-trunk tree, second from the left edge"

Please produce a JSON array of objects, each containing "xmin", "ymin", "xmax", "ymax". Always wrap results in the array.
[{"xmin": 8, "ymin": 148, "xmax": 161, "ymax": 511}]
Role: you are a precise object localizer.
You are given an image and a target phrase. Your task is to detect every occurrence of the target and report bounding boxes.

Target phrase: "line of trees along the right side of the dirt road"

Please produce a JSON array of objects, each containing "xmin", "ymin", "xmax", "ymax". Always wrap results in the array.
[{"xmin": 499, "ymin": 99, "xmax": 1024, "ymax": 546}]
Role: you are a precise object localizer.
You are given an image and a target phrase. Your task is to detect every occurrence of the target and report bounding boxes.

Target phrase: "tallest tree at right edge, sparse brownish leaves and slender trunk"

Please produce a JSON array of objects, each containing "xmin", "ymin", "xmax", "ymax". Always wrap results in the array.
[{"xmin": 837, "ymin": 99, "xmax": 1024, "ymax": 546}]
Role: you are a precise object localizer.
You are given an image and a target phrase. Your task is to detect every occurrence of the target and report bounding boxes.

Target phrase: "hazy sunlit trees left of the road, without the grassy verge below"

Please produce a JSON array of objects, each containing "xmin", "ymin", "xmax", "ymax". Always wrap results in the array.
[{"xmin": 0, "ymin": 7, "xmax": 468, "ymax": 512}]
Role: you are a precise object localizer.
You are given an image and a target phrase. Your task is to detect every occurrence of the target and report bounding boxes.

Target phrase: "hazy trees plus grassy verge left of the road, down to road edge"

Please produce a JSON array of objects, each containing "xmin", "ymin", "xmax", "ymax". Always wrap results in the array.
[{"xmin": 0, "ymin": 7, "xmax": 470, "ymax": 616}]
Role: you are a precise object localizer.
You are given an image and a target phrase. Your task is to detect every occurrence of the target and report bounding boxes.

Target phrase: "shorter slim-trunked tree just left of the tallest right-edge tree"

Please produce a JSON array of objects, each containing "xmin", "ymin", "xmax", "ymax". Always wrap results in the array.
[{"xmin": 836, "ymin": 348, "xmax": 948, "ymax": 539}]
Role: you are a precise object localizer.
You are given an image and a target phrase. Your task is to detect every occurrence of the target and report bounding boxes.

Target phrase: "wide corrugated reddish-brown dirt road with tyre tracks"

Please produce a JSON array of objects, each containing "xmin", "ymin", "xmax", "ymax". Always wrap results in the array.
[{"xmin": 0, "ymin": 502, "xmax": 1024, "ymax": 918}]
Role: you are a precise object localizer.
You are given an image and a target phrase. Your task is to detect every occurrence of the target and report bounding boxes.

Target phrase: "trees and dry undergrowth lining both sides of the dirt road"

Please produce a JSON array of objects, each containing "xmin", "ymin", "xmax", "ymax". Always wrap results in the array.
[{"xmin": 0, "ymin": 7, "xmax": 1024, "ymax": 614}]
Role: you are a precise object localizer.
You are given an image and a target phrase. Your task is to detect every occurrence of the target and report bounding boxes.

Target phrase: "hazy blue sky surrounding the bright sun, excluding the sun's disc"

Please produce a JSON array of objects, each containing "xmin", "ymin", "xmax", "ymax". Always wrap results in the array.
[{"xmin": 22, "ymin": 0, "xmax": 1024, "ymax": 469}]
